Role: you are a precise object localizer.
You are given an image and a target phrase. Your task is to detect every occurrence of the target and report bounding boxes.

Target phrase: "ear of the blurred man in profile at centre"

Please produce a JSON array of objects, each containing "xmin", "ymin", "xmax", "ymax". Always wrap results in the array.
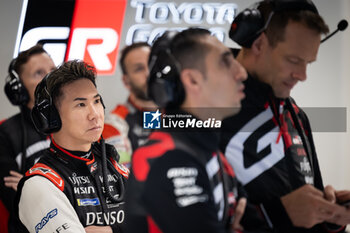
[{"xmin": 181, "ymin": 69, "xmax": 204, "ymax": 93}]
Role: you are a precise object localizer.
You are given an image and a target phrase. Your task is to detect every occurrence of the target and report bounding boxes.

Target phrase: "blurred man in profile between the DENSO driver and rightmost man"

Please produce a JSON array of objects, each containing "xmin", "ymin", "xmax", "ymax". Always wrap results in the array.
[{"xmin": 126, "ymin": 28, "xmax": 272, "ymax": 233}]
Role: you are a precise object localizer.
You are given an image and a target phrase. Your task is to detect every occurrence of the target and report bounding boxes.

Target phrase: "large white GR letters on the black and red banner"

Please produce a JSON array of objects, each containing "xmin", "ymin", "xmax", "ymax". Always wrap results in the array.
[{"xmin": 19, "ymin": 27, "xmax": 119, "ymax": 74}]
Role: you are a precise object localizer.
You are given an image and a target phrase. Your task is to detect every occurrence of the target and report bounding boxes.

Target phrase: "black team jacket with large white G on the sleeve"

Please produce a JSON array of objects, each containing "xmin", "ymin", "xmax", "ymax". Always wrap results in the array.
[{"xmin": 220, "ymin": 76, "xmax": 340, "ymax": 232}]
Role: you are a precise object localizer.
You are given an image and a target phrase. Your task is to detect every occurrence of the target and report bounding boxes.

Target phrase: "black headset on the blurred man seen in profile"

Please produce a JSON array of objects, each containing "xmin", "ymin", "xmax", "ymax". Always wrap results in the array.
[{"xmin": 147, "ymin": 31, "xmax": 185, "ymax": 107}]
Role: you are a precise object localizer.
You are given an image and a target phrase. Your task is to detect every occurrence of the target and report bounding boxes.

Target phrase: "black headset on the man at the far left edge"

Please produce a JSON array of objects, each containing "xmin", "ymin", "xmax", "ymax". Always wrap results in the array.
[{"xmin": 4, "ymin": 59, "xmax": 30, "ymax": 106}]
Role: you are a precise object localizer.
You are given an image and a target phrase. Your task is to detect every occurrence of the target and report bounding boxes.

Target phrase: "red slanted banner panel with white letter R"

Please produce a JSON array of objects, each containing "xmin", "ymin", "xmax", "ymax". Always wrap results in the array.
[{"xmin": 65, "ymin": 0, "xmax": 126, "ymax": 75}]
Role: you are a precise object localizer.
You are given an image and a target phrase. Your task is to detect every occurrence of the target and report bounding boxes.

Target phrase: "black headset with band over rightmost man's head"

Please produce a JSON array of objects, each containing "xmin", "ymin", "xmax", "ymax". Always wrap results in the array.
[{"xmin": 229, "ymin": 0, "xmax": 318, "ymax": 48}]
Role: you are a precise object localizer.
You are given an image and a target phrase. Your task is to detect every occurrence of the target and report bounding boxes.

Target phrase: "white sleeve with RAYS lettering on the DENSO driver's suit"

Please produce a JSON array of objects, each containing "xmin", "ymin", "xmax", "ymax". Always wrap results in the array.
[{"xmin": 18, "ymin": 176, "xmax": 85, "ymax": 233}]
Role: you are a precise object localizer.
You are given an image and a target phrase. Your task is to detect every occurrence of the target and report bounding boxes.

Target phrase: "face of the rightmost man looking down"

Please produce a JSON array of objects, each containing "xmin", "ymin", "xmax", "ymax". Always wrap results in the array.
[{"xmin": 257, "ymin": 22, "xmax": 321, "ymax": 98}]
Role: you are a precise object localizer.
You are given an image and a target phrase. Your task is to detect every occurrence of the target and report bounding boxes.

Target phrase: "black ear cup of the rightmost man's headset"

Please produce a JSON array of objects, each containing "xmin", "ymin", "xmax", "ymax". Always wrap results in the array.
[{"xmin": 229, "ymin": 8, "xmax": 264, "ymax": 48}]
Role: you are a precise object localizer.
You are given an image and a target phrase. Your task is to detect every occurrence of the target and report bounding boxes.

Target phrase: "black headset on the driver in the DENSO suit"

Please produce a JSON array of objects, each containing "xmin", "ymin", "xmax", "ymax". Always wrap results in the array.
[{"xmin": 31, "ymin": 73, "xmax": 62, "ymax": 134}]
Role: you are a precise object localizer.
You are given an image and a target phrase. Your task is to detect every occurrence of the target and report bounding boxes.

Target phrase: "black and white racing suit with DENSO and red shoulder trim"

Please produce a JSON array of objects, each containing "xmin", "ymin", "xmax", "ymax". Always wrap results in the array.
[{"xmin": 17, "ymin": 140, "xmax": 128, "ymax": 233}]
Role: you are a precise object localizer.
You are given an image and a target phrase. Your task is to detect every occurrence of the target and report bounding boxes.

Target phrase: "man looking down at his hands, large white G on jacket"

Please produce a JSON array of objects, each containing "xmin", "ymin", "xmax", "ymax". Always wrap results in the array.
[{"xmin": 221, "ymin": 0, "xmax": 350, "ymax": 233}]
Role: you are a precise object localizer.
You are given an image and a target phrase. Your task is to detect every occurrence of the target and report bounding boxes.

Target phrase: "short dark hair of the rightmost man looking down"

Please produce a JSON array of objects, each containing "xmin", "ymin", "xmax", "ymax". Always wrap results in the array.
[{"xmin": 258, "ymin": 1, "xmax": 329, "ymax": 47}]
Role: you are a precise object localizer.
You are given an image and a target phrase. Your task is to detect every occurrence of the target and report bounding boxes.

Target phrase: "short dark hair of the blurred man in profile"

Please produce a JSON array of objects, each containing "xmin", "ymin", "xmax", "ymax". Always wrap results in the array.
[{"xmin": 170, "ymin": 28, "xmax": 210, "ymax": 72}]
